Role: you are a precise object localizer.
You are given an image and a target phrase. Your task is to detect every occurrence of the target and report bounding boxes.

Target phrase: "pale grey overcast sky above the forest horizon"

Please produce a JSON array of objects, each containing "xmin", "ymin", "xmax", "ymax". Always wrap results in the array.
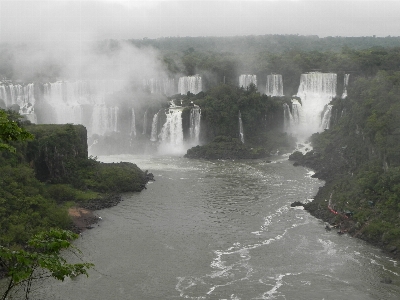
[{"xmin": 0, "ymin": 0, "xmax": 400, "ymax": 42}]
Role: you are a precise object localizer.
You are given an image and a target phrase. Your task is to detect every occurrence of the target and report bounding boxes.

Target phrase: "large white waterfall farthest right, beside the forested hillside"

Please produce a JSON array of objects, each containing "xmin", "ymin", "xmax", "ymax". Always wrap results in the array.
[{"xmin": 292, "ymin": 72, "xmax": 337, "ymax": 137}]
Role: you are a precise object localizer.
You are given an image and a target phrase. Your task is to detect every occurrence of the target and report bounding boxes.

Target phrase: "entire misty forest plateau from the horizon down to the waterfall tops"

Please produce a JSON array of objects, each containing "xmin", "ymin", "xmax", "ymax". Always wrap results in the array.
[{"xmin": 0, "ymin": 35, "xmax": 400, "ymax": 89}]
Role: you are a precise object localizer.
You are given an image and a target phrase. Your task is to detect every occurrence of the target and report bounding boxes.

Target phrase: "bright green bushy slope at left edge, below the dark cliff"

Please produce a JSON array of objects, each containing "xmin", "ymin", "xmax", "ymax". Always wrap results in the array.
[{"xmin": 0, "ymin": 165, "xmax": 70, "ymax": 245}]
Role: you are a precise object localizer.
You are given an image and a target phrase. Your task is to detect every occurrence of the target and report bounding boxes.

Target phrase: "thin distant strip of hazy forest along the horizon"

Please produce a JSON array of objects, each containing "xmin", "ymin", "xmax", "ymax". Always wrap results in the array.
[{"xmin": 127, "ymin": 34, "xmax": 400, "ymax": 55}]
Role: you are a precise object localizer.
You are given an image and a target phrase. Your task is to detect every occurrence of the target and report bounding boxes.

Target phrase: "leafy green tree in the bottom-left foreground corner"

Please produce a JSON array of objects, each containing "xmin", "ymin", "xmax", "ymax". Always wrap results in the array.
[{"xmin": 0, "ymin": 229, "xmax": 94, "ymax": 300}]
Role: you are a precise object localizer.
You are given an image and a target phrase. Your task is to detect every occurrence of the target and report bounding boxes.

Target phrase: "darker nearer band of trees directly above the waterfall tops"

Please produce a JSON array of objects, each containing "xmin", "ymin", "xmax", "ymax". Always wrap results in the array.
[{"xmin": 162, "ymin": 46, "xmax": 400, "ymax": 95}]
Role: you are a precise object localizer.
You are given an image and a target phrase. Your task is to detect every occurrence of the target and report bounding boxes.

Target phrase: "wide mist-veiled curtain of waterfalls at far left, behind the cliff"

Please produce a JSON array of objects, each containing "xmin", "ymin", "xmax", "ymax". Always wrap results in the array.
[{"xmin": 0, "ymin": 80, "xmax": 131, "ymax": 135}]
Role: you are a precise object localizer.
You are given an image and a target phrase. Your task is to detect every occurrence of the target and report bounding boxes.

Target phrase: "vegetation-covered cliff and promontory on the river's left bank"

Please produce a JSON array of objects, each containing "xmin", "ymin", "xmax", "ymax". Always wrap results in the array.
[{"xmin": 0, "ymin": 110, "xmax": 146, "ymax": 247}]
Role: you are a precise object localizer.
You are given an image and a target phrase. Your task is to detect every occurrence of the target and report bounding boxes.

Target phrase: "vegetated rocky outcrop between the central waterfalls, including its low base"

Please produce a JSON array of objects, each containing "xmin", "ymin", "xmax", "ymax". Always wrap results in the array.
[{"xmin": 174, "ymin": 84, "xmax": 295, "ymax": 158}]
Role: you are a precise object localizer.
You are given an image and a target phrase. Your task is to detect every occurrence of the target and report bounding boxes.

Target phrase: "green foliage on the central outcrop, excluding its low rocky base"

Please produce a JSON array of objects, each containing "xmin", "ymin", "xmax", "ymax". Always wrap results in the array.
[{"xmin": 179, "ymin": 84, "xmax": 294, "ymax": 153}]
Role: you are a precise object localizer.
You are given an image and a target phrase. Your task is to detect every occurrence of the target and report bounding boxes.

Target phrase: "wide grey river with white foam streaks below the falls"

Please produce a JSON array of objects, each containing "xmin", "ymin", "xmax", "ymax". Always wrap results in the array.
[{"xmin": 39, "ymin": 155, "xmax": 400, "ymax": 300}]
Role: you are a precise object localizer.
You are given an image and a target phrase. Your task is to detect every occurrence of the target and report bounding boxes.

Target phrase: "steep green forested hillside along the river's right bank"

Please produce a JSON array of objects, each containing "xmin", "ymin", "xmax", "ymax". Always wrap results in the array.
[{"xmin": 292, "ymin": 70, "xmax": 400, "ymax": 253}]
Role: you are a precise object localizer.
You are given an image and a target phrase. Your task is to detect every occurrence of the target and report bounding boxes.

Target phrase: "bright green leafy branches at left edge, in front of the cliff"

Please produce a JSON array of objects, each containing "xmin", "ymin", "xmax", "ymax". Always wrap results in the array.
[{"xmin": 0, "ymin": 109, "xmax": 33, "ymax": 152}]
